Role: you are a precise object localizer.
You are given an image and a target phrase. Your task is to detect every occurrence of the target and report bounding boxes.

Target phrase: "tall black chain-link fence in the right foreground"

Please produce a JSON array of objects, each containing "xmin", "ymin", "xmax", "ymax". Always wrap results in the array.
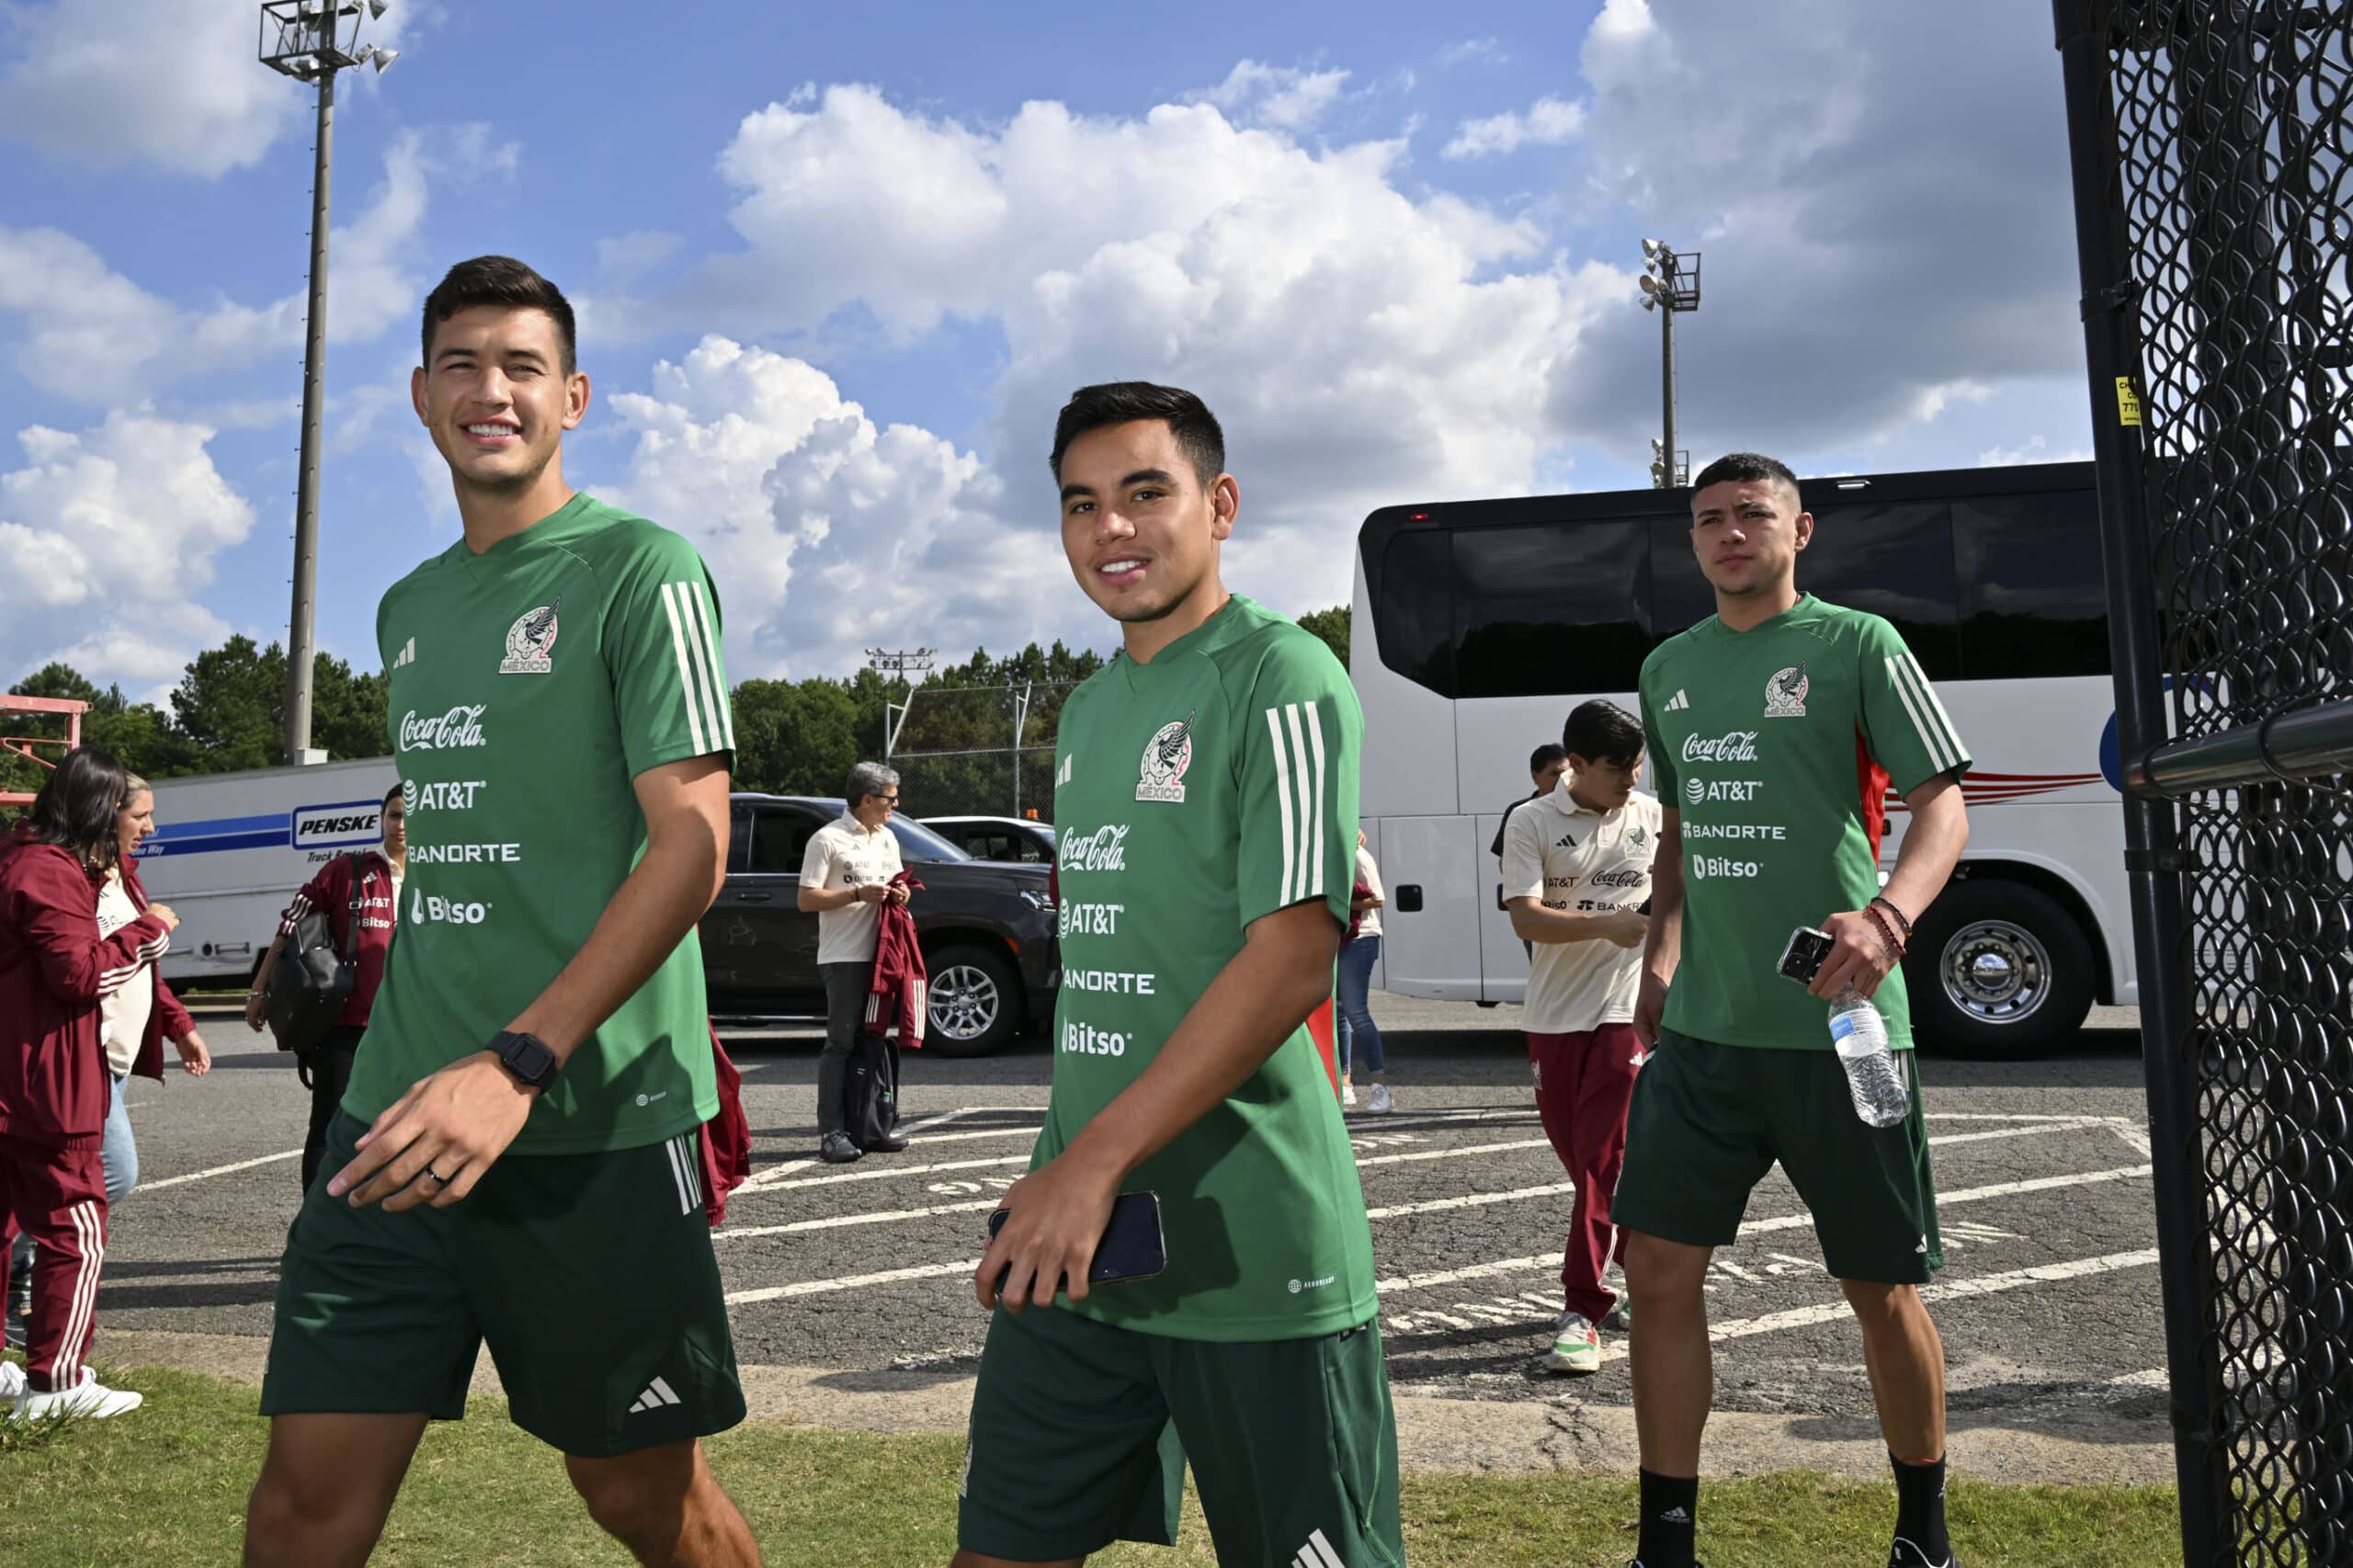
[{"xmin": 2054, "ymin": 0, "xmax": 2353, "ymax": 1568}]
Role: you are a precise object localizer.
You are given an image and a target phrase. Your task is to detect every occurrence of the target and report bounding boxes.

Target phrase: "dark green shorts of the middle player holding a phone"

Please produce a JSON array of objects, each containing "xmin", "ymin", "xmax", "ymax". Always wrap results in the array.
[{"xmin": 955, "ymin": 1307, "xmax": 1404, "ymax": 1568}]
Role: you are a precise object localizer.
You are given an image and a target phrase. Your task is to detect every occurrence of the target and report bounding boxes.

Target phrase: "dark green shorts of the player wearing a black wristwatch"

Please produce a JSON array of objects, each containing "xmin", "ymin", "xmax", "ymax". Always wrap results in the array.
[{"xmin": 261, "ymin": 1111, "xmax": 744, "ymax": 1460}]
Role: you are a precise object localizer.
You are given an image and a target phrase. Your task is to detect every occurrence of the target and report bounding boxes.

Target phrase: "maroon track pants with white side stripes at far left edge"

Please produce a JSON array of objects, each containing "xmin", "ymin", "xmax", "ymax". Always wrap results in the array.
[{"xmin": 0, "ymin": 1135, "xmax": 106, "ymax": 1392}]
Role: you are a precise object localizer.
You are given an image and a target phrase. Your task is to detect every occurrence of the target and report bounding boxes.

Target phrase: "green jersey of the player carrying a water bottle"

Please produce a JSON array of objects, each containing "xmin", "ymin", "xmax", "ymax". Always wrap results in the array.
[{"xmin": 1643, "ymin": 596, "xmax": 1970, "ymax": 1050}]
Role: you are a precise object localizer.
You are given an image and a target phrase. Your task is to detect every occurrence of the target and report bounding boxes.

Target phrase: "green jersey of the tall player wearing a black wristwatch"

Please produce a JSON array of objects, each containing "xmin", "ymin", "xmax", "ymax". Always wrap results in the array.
[{"xmin": 344, "ymin": 494, "xmax": 734, "ymax": 1153}]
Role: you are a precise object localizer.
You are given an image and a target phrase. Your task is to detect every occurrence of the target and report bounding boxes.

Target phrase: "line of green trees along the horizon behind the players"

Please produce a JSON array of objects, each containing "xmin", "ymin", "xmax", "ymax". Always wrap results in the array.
[{"xmin": 0, "ymin": 605, "xmax": 1348, "ymax": 796}]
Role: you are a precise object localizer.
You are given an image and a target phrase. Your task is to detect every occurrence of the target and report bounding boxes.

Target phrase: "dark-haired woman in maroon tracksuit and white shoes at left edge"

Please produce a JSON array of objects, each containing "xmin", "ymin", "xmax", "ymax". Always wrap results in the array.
[{"xmin": 0, "ymin": 746, "xmax": 179, "ymax": 1417}]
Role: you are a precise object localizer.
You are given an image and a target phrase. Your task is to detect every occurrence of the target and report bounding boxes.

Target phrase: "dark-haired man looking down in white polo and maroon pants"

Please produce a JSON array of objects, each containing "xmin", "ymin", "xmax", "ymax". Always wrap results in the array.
[{"xmin": 1504, "ymin": 701, "xmax": 1659, "ymax": 1372}]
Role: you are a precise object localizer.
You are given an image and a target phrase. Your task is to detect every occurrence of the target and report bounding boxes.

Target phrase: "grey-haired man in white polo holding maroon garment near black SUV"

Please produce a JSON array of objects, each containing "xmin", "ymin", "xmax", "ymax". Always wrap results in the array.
[{"xmin": 800, "ymin": 763, "xmax": 908, "ymax": 1165}]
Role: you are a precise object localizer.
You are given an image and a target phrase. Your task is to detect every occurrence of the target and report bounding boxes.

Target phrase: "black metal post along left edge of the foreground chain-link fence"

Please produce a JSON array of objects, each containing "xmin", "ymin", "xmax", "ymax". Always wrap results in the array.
[{"xmin": 2052, "ymin": 0, "xmax": 2238, "ymax": 1563}]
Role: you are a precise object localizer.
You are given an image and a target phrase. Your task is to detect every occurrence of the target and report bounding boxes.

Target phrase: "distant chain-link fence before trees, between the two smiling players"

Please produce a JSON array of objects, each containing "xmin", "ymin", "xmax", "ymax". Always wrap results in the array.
[{"xmin": 890, "ymin": 680, "xmax": 1077, "ymax": 822}]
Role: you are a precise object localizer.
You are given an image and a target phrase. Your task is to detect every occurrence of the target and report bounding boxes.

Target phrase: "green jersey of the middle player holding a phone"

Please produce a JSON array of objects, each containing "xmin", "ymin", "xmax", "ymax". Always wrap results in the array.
[{"xmin": 1030, "ymin": 598, "xmax": 1374, "ymax": 1340}]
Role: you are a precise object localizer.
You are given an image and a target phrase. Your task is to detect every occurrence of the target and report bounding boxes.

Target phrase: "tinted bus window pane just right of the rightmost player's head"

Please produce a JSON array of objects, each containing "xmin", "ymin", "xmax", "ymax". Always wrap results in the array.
[{"xmin": 1798, "ymin": 502, "xmax": 1962, "ymax": 680}]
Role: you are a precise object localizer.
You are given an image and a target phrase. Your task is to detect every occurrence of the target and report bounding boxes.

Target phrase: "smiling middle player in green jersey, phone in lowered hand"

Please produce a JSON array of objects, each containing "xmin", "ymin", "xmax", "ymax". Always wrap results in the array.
[{"xmin": 955, "ymin": 381, "xmax": 1404, "ymax": 1568}]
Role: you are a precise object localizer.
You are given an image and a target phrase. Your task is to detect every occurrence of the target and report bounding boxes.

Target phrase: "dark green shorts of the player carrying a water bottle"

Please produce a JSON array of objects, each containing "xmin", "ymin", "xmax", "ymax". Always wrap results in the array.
[{"xmin": 1609, "ymin": 1028, "xmax": 1944, "ymax": 1286}]
